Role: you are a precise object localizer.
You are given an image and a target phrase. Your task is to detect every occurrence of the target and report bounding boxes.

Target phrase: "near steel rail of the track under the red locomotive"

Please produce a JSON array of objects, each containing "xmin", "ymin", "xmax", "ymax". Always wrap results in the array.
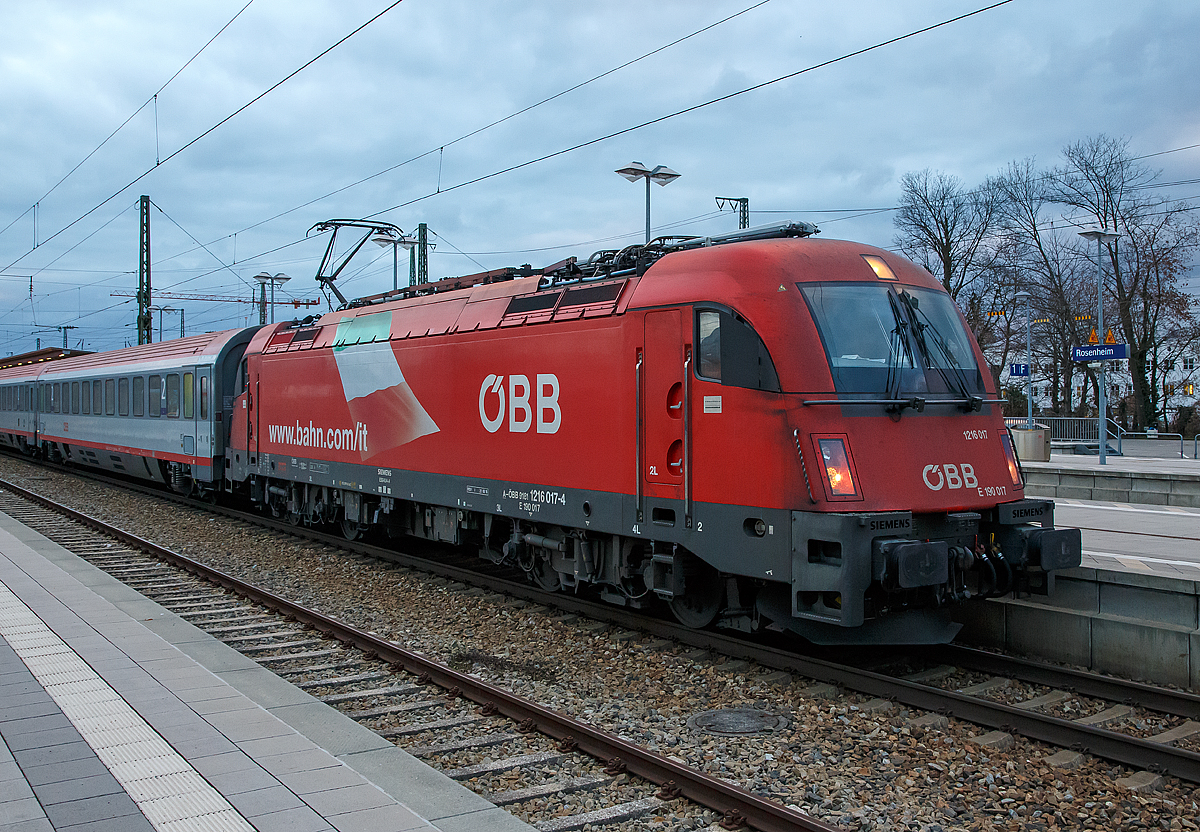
[{"xmin": 7, "ymin": 463, "xmax": 1200, "ymax": 783}]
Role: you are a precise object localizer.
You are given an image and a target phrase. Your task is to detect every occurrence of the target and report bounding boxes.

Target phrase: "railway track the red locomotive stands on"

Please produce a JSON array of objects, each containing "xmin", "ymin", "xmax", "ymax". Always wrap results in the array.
[{"xmin": 2, "ymin": 461, "xmax": 1200, "ymax": 825}]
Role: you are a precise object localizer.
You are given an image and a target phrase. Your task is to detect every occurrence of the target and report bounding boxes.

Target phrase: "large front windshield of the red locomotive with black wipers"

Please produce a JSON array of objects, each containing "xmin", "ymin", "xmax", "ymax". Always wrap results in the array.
[{"xmin": 798, "ymin": 282, "xmax": 984, "ymax": 396}]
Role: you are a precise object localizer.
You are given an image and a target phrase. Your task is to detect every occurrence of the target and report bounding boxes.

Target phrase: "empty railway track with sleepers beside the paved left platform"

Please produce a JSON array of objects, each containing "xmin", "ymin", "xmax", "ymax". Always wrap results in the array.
[{"xmin": 0, "ymin": 483, "xmax": 836, "ymax": 832}]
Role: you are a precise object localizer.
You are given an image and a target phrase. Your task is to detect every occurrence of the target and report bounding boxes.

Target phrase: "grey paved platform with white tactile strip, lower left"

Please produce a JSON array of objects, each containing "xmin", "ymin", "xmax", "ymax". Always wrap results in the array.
[{"xmin": 0, "ymin": 513, "xmax": 533, "ymax": 832}]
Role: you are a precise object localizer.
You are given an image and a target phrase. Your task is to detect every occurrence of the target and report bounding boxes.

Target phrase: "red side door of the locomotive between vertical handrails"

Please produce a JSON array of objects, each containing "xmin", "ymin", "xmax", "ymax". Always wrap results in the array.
[{"xmin": 640, "ymin": 310, "xmax": 691, "ymax": 520}]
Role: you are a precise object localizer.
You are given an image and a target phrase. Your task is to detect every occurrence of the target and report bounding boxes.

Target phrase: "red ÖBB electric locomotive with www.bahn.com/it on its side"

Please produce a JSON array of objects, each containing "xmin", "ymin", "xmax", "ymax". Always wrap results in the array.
[{"xmin": 224, "ymin": 223, "xmax": 1081, "ymax": 644}]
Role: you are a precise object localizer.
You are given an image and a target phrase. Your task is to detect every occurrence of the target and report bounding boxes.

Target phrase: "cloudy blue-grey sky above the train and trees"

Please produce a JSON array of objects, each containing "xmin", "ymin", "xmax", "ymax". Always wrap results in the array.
[{"xmin": 0, "ymin": 0, "xmax": 1200, "ymax": 354}]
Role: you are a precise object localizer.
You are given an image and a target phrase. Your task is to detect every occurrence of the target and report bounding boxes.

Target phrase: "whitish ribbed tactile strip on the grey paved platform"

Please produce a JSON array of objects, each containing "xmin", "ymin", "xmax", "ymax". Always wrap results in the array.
[{"xmin": 0, "ymin": 583, "xmax": 253, "ymax": 832}]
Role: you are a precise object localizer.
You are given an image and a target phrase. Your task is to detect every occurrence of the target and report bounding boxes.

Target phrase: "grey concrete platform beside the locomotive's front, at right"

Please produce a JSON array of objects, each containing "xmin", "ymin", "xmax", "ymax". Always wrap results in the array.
[{"xmin": 954, "ymin": 449, "xmax": 1200, "ymax": 690}]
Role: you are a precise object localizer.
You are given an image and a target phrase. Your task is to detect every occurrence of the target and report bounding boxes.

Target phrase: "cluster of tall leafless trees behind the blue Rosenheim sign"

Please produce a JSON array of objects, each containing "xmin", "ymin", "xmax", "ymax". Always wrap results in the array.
[{"xmin": 895, "ymin": 136, "xmax": 1200, "ymax": 429}]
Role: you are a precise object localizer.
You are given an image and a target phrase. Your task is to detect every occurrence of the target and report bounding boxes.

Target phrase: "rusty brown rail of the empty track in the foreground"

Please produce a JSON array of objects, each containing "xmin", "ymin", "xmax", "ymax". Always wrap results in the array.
[{"xmin": 0, "ymin": 480, "xmax": 841, "ymax": 832}]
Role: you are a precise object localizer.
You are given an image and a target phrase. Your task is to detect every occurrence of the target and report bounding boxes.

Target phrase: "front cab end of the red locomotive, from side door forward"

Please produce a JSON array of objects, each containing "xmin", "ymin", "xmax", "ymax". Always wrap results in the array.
[{"xmin": 631, "ymin": 230, "xmax": 1081, "ymax": 644}]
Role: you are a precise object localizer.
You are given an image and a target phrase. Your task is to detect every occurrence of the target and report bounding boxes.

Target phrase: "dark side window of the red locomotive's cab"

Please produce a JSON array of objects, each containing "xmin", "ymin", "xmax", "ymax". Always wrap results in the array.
[{"xmin": 696, "ymin": 310, "xmax": 780, "ymax": 393}]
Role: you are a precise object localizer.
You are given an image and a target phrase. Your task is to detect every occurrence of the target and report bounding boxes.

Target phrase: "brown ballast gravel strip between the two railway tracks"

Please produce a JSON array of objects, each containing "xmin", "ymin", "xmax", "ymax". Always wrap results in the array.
[{"xmin": 0, "ymin": 456, "xmax": 1200, "ymax": 832}]
